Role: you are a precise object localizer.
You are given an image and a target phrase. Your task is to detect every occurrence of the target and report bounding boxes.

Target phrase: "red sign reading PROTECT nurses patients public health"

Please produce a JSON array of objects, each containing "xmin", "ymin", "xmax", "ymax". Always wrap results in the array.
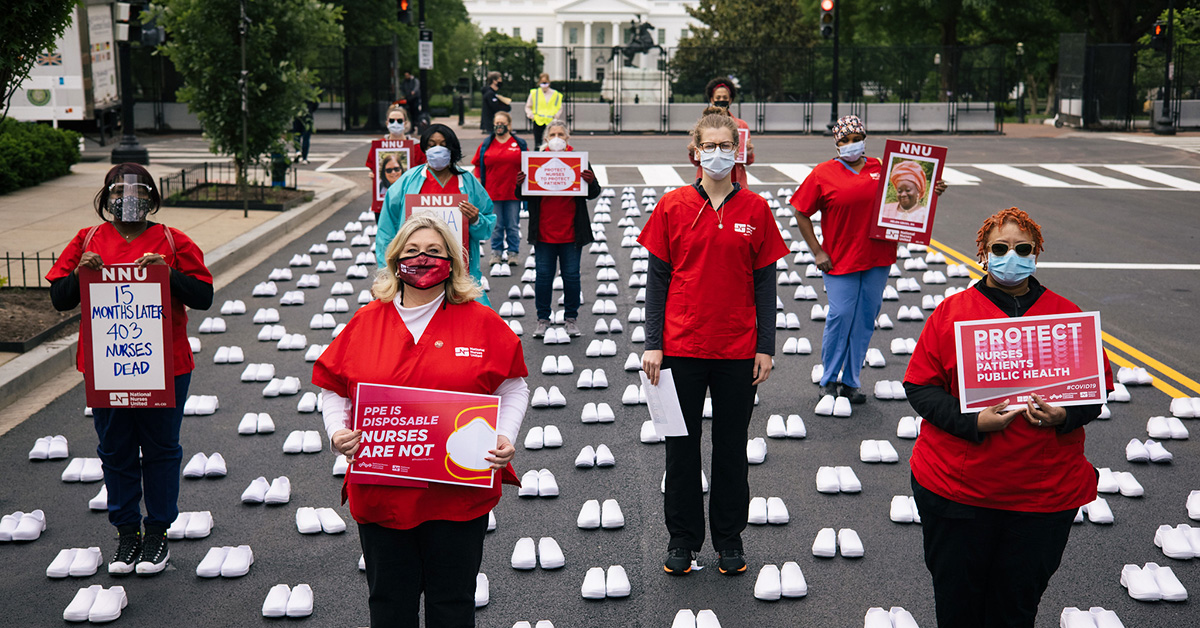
[{"xmin": 954, "ymin": 312, "xmax": 1106, "ymax": 412}]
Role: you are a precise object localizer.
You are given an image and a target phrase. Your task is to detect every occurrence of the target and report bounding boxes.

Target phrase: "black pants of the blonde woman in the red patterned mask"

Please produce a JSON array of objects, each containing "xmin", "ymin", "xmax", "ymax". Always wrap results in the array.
[{"xmin": 359, "ymin": 515, "xmax": 487, "ymax": 628}]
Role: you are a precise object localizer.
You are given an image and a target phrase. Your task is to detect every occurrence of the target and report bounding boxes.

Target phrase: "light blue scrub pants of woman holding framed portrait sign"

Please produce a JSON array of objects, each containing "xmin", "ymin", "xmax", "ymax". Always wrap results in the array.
[{"xmin": 821, "ymin": 267, "xmax": 888, "ymax": 388}]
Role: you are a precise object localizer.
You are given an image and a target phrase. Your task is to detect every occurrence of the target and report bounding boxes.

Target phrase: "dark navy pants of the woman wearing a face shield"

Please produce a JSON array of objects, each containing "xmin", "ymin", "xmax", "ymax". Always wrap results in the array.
[{"xmin": 91, "ymin": 373, "xmax": 192, "ymax": 530}]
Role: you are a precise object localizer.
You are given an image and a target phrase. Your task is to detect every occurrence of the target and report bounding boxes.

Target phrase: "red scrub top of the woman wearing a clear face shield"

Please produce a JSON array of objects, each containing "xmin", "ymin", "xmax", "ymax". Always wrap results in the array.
[{"xmin": 46, "ymin": 222, "xmax": 212, "ymax": 375}]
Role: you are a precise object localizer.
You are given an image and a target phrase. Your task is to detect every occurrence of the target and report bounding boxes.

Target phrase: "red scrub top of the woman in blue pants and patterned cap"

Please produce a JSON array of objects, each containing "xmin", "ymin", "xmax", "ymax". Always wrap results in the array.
[{"xmin": 791, "ymin": 157, "xmax": 896, "ymax": 275}]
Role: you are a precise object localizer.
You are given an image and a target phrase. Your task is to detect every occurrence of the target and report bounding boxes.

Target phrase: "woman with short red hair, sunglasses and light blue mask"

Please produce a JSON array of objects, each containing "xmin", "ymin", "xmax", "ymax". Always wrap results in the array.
[{"xmin": 904, "ymin": 208, "xmax": 1112, "ymax": 628}]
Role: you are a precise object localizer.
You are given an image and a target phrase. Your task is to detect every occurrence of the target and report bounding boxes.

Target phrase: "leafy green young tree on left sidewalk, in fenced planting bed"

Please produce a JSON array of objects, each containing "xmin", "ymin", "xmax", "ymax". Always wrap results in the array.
[{"xmin": 154, "ymin": 0, "xmax": 342, "ymax": 173}]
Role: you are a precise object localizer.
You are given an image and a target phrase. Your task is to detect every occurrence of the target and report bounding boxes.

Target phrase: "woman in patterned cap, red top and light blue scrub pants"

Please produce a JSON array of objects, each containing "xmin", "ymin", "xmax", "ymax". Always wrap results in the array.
[{"xmin": 791, "ymin": 115, "xmax": 946, "ymax": 409}]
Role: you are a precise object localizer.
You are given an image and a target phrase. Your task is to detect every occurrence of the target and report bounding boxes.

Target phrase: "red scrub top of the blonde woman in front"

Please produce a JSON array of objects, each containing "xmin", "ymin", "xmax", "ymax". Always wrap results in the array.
[{"xmin": 312, "ymin": 300, "xmax": 529, "ymax": 530}]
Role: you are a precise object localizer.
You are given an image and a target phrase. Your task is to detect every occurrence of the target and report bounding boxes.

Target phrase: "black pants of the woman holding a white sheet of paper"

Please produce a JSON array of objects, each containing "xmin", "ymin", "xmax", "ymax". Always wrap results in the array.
[{"xmin": 662, "ymin": 355, "xmax": 757, "ymax": 551}]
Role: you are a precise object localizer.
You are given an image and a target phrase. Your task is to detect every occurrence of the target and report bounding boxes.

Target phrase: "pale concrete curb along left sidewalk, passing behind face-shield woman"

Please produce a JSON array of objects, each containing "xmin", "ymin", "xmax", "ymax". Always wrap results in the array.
[{"xmin": 0, "ymin": 184, "xmax": 358, "ymax": 417}]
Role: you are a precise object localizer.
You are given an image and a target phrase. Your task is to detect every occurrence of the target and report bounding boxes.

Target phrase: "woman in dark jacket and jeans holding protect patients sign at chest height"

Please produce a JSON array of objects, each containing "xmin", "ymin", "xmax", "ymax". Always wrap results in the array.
[{"xmin": 516, "ymin": 120, "xmax": 600, "ymax": 337}]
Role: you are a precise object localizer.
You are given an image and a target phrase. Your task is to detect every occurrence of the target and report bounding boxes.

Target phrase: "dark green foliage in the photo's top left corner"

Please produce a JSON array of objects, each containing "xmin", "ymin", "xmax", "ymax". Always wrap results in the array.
[{"xmin": 0, "ymin": 0, "xmax": 78, "ymax": 120}]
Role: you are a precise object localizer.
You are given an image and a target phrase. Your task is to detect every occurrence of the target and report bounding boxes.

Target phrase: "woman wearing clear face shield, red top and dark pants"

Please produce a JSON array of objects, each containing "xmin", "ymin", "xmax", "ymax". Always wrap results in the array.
[{"xmin": 46, "ymin": 163, "xmax": 212, "ymax": 575}]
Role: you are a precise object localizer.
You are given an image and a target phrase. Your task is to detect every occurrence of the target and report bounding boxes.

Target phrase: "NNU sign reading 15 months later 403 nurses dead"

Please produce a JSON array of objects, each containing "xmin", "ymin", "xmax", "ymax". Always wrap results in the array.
[{"xmin": 79, "ymin": 264, "xmax": 175, "ymax": 408}]
